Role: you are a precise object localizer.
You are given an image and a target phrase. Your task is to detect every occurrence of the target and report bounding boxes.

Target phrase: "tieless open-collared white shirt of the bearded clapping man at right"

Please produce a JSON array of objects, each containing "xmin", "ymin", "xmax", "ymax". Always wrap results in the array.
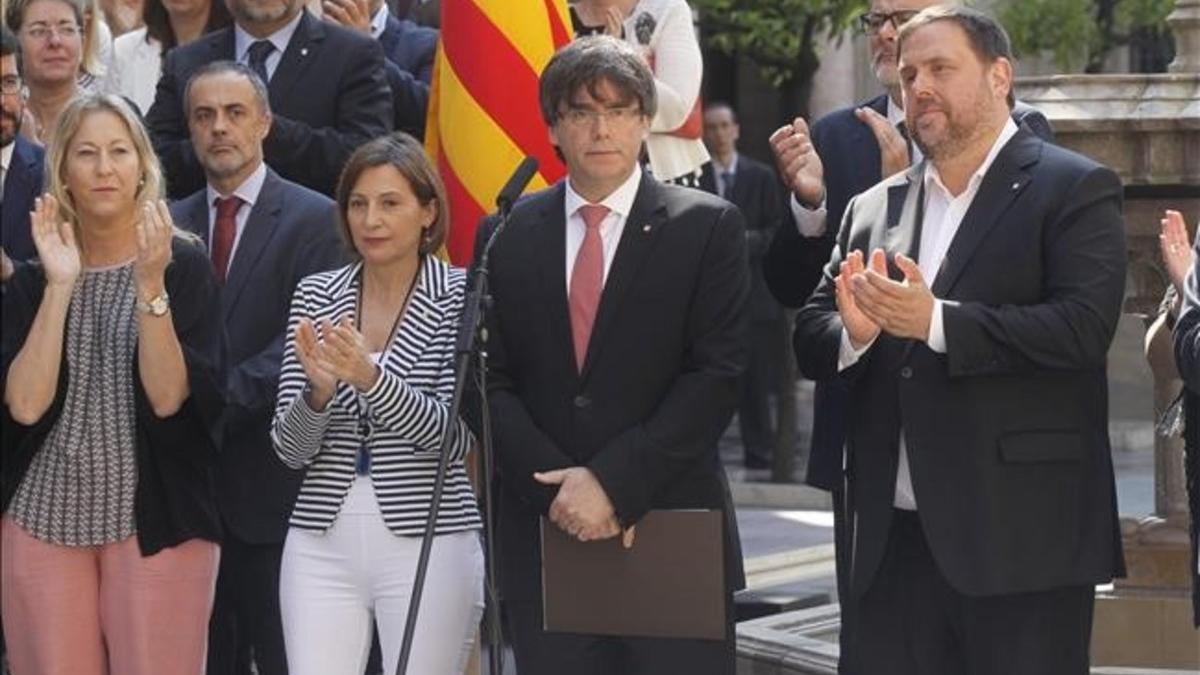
[{"xmin": 838, "ymin": 118, "xmax": 1016, "ymax": 510}]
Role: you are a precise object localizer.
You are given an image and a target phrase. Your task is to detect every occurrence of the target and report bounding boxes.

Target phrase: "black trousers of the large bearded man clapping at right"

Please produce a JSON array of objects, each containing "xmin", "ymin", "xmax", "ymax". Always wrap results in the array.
[{"xmin": 842, "ymin": 510, "xmax": 1094, "ymax": 675}]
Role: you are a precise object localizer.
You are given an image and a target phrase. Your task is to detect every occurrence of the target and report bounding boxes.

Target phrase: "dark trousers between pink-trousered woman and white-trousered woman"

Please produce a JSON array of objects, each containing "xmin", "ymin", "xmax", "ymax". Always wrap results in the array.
[{"xmin": 208, "ymin": 530, "xmax": 288, "ymax": 675}]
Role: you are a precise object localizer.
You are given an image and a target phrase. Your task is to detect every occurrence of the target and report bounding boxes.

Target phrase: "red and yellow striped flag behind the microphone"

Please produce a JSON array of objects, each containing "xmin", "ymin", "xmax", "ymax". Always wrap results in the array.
[{"xmin": 425, "ymin": 0, "xmax": 571, "ymax": 265}]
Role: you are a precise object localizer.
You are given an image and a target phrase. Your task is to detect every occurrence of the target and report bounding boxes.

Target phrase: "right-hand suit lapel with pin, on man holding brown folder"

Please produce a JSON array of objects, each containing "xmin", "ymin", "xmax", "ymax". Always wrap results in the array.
[{"xmin": 580, "ymin": 173, "xmax": 666, "ymax": 380}]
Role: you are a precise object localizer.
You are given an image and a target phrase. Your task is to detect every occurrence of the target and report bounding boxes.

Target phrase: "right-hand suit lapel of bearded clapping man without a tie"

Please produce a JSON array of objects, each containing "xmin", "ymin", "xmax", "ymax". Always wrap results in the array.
[{"xmin": 930, "ymin": 130, "xmax": 1042, "ymax": 298}]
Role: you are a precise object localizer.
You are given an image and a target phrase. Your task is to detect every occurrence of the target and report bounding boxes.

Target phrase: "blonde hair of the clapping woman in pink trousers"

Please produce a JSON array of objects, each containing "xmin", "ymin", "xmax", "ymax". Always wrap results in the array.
[{"xmin": 46, "ymin": 92, "xmax": 163, "ymax": 227}]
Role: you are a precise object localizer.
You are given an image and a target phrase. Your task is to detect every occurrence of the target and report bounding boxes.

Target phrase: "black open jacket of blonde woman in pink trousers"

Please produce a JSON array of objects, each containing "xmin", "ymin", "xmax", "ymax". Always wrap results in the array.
[{"xmin": 0, "ymin": 237, "xmax": 223, "ymax": 556}]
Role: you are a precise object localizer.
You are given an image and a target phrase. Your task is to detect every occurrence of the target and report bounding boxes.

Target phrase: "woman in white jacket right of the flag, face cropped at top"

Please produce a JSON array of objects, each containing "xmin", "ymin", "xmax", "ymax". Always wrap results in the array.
[{"xmin": 571, "ymin": 0, "xmax": 708, "ymax": 181}]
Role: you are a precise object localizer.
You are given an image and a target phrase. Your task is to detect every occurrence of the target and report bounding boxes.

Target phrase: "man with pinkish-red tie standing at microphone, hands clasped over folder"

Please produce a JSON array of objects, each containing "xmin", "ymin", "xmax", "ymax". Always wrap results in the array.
[{"xmin": 481, "ymin": 37, "xmax": 749, "ymax": 675}]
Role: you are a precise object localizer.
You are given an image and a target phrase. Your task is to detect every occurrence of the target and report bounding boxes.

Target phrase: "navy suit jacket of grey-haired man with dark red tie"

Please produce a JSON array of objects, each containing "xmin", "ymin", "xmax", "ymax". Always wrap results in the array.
[{"xmin": 172, "ymin": 169, "xmax": 344, "ymax": 544}]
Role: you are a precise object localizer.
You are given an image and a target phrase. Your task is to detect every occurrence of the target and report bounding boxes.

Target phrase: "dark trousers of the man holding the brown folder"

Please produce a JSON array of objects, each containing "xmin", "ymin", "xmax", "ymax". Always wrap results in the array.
[{"xmin": 505, "ymin": 593, "xmax": 736, "ymax": 675}]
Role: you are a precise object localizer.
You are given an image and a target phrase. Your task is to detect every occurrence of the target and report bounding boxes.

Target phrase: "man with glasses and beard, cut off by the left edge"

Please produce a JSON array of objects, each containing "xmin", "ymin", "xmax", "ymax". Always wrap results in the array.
[{"xmin": 0, "ymin": 26, "xmax": 44, "ymax": 281}]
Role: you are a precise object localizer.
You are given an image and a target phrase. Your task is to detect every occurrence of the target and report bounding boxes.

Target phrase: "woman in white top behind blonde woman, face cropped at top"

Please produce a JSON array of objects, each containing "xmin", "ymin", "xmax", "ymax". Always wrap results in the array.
[{"xmin": 107, "ymin": 0, "xmax": 233, "ymax": 114}]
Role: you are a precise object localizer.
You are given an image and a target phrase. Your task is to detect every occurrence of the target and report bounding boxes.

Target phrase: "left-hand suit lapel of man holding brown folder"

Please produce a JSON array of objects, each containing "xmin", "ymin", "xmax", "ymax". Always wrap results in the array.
[{"xmin": 535, "ymin": 179, "xmax": 578, "ymax": 375}]
